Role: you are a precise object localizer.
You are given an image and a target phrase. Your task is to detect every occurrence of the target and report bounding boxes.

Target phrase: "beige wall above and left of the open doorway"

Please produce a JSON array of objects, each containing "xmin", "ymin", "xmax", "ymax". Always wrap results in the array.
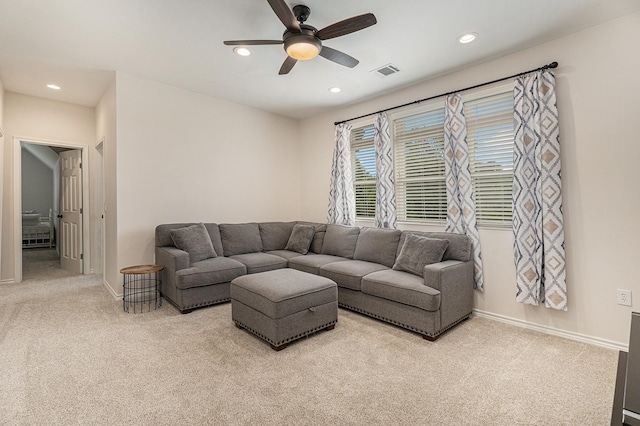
[{"xmin": 0, "ymin": 92, "xmax": 95, "ymax": 281}]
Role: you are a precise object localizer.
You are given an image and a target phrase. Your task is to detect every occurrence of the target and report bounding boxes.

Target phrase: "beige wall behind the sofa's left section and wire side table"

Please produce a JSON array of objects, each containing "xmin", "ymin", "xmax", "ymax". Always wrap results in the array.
[{"xmin": 99, "ymin": 73, "xmax": 301, "ymax": 294}]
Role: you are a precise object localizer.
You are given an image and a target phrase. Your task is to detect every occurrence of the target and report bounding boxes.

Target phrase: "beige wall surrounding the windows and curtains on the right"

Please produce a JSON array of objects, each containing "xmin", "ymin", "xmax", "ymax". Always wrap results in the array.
[{"xmin": 300, "ymin": 14, "xmax": 640, "ymax": 345}]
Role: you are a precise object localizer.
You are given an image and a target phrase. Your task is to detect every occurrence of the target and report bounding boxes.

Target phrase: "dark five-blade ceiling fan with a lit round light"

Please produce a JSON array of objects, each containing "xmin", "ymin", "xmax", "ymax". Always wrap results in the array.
[{"xmin": 224, "ymin": 0, "xmax": 378, "ymax": 75}]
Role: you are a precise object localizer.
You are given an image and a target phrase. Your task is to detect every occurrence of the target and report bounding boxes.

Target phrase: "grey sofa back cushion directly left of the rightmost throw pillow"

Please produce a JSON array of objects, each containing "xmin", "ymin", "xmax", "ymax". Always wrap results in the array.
[{"xmin": 353, "ymin": 228, "xmax": 402, "ymax": 268}]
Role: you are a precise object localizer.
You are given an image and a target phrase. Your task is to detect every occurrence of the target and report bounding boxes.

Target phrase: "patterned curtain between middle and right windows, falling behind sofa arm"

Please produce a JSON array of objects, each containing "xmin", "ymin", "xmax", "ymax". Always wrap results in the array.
[{"xmin": 444, "ymin": 94, "xmax": 484, "ymax": 291}]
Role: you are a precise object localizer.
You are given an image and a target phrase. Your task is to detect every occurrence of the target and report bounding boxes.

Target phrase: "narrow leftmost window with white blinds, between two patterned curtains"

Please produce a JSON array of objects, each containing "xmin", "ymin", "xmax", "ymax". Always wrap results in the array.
[{"xmin": 351, "ymin": 124, "xmax": 376, "ymax": 218}]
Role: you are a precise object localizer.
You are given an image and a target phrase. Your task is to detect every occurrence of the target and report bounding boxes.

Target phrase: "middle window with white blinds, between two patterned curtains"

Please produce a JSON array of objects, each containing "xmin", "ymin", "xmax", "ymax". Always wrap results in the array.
[{"xmin": 393, "ymin": 108, "xmax": 447, "ymax": 222}]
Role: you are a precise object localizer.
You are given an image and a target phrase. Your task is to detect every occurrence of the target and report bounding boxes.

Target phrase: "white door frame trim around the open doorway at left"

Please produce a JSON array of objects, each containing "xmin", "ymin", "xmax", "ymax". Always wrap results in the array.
[{"xmin": 13, "ymin": 136, "xmax": 91, "ymax": 283}]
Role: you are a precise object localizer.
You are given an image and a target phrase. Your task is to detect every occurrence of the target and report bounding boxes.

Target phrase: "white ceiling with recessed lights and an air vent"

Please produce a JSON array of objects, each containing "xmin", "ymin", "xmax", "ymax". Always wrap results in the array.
[{"xmin": 0, "ymin": 0, "xmax": 640, "ymax": 118}]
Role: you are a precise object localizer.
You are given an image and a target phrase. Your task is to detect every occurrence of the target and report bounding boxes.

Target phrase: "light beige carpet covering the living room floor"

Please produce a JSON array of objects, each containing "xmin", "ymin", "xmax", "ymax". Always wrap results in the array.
[{"xmin": 0, "ymin": 276, "xmax": 617, "ymax": 425}]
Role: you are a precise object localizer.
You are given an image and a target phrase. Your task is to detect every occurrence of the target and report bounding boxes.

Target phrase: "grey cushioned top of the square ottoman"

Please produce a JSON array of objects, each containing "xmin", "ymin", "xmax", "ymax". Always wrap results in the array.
[{"xmin": 231, "ymin": 269, "xmax": 338, "ymax": 319}]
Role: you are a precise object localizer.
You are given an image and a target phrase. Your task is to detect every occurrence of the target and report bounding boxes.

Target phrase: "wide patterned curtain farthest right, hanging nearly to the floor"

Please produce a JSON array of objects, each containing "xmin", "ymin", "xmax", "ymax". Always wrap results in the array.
[{"xmin": 513, "ymin": 71, "xmax": 567, "ymax": 311}]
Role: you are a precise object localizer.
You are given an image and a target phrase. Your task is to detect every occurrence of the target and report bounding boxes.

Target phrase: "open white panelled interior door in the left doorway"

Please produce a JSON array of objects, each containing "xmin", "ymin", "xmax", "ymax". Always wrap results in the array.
[{"xmin": 58, "ymin": 149, "xmax": 82, "ymax": 274}]
